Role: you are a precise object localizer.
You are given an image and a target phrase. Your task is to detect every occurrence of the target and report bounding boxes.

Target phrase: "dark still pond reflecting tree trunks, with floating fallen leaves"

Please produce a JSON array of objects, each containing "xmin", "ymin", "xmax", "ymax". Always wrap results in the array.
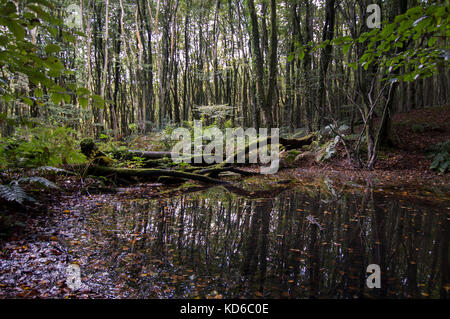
[{"xmin": 65, "ymin": 180, "xmax": 450, "ymax": 298}]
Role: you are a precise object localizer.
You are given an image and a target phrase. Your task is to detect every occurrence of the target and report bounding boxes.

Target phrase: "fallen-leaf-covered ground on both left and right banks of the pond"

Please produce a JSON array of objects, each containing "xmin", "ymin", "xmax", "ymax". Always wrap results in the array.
[{"xmin": 0, "ymin": 107, "xmax": 450, "ymax": 298}]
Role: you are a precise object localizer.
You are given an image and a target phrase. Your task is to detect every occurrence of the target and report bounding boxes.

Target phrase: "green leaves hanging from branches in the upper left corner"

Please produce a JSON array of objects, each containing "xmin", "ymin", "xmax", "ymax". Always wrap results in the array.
[{"xmin": 0, "ymin": 0, "xmax": 104, "ymax": 130}]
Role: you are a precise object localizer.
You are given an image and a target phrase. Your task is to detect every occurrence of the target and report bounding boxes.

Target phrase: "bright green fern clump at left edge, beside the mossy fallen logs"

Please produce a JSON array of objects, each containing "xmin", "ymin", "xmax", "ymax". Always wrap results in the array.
[{"xmin": 0, "ymin": 127, "xmax": 86, "ymax": 167}]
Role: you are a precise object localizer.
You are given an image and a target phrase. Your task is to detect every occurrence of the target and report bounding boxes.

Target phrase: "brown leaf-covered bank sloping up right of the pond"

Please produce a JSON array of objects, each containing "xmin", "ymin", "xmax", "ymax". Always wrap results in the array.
[{"xmin": 288, "ymin": 106, "xmax": 450, "ymax": 187}]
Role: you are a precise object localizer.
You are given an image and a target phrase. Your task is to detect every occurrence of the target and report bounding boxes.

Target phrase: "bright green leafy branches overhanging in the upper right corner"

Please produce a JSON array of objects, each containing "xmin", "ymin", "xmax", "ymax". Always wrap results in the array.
[{"xmin": 356, "ymin": 3, "xmax": 450, "ymax": 82}]
